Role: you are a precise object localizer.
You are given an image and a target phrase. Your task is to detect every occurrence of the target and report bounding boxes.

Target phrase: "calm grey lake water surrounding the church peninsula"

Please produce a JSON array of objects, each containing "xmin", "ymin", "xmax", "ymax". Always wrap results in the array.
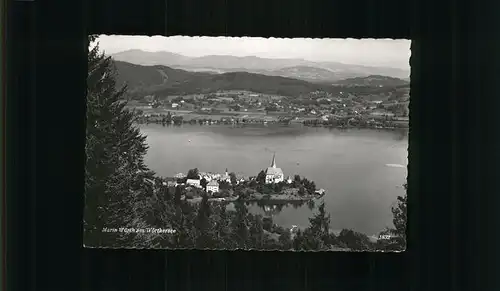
[{"xmin": 140, "ymin": 124, "xmax": 408, "ymax": 235}]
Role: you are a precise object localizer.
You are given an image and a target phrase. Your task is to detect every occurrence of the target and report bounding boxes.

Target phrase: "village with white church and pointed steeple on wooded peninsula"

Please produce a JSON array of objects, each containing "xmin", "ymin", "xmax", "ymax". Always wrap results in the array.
[{"xmin": 159, "ymin": 156, "xmax": 326, "ymax": 203}]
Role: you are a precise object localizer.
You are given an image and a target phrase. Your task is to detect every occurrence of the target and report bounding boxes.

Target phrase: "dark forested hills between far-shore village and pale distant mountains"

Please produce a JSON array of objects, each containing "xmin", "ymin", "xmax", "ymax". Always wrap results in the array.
[{"xmin": 114, "ymin": 60, "xmax": 409, "ymax": 98}]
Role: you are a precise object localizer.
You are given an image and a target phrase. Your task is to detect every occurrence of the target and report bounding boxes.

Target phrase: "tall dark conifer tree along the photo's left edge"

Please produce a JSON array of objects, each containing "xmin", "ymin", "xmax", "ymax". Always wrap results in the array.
[{"xmin": 84, "ymin": 36, "xmax": 153, "ymax": 246}]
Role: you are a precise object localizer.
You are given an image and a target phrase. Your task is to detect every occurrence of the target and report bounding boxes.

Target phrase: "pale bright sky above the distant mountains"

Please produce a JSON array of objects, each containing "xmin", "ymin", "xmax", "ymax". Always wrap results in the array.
[{"xmin": 98, "ymin": 35, "xmax": 411, "ymax": 70}]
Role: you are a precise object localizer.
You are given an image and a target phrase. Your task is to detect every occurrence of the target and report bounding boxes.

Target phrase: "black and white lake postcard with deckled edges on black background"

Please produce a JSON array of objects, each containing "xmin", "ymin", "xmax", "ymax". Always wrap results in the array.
[{"xmin": 83, "ymin": 35, "xmax": 411, "ymax": 252}]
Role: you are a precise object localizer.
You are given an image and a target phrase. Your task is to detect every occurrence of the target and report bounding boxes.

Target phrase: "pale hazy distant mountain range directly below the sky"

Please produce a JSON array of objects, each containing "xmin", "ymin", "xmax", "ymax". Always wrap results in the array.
[{"xmin": 112, "ymin": 49, "xmax": 410, "ymax": 83}]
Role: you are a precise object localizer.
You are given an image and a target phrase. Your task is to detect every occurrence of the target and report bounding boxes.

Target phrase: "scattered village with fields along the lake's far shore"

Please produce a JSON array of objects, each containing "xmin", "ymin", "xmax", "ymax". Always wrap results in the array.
[{"xmin": 127, "ymin": 87, "xmax": 409, "ymax": 128}]
